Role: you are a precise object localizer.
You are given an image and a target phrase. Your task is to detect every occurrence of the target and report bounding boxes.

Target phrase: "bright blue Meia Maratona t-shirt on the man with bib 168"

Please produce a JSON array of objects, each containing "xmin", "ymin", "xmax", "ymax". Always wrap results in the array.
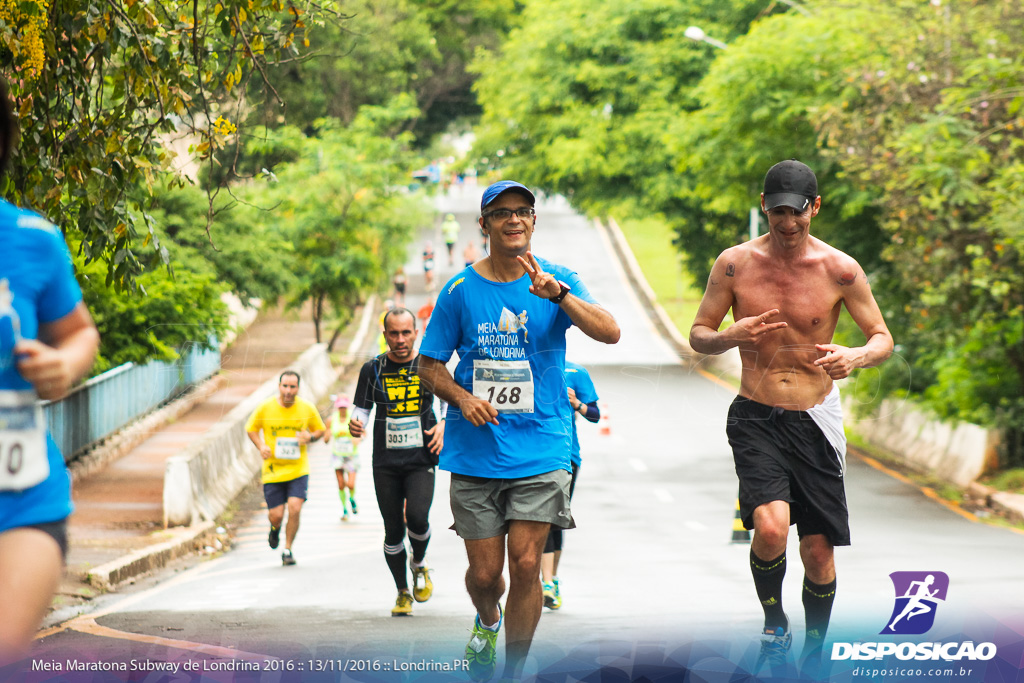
[{"xmin": 420, "ymin": 257, "xmax": 597, "ymax": 479}]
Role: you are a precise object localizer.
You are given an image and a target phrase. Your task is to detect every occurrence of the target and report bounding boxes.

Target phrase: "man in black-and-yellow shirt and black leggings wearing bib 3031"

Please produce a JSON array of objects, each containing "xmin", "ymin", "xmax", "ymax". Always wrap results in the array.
[{"xmin": 348, "ymin": 308, "xmax": 447, "ymax": 616}]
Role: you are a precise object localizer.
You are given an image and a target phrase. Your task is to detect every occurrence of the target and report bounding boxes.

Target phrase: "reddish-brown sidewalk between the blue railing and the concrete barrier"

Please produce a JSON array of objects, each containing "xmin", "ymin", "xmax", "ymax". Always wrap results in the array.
[{"xmin": 51, "ymin": 309, "xmax": 372, "ymax": 616}]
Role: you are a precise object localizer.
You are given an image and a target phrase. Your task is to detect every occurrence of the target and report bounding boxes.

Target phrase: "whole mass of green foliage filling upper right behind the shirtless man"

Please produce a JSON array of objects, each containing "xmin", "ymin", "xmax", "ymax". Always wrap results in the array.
[{"xmin": 475, "ymin": 0, "xmax": 1024, "ymax": 459}]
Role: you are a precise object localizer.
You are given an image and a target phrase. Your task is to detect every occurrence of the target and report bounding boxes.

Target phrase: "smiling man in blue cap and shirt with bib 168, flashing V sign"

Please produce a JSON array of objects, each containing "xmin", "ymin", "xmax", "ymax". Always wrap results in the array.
[{"xmin": 420, "ymin": 180, "xmax": 620, "ymax": 681}]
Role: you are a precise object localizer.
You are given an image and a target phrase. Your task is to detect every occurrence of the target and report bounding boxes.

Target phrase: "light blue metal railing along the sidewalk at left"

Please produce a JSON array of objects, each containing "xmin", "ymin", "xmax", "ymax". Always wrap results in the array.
[{"xmin": 43, "ymin": 346, "xmax": 220, "ymax": 462}]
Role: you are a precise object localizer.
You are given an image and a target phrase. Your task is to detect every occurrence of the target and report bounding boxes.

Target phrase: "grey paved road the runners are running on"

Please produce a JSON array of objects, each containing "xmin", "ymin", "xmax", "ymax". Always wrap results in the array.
[{"xmin": 26, "ymin": 187, "xmax": 1024, "ymax": 681}]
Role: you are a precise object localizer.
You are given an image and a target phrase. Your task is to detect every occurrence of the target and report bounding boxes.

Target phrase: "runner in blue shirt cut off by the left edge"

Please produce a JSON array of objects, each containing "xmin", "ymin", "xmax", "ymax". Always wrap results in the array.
[{"xmin": 0, "ymin": 79, "xmax": 99, "ymax": 667}]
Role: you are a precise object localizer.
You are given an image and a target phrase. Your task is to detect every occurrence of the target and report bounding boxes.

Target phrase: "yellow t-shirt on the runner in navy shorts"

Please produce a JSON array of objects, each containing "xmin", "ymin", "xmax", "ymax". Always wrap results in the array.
[{"xmin": 246, "ymin": 396, "xmax": 326, "ymax": 483}]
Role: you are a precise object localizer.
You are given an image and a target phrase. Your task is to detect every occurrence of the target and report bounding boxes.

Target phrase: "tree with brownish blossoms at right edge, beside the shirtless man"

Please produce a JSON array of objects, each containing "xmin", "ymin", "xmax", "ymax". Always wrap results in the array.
[{"xmin": 820, "ymin": 2, "xmax": 1024, "ymax": 464}]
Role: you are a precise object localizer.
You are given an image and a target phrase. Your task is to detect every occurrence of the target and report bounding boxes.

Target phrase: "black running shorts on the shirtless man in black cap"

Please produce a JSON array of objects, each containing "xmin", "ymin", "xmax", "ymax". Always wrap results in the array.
[{"xmin": 726, "ymin": 396, "xmax": 850, "ymax": 546}]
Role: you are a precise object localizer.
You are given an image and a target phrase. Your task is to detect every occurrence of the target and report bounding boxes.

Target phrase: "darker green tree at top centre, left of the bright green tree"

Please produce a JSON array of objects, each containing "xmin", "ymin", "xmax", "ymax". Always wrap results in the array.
[{"xmin": 247, "ymin": 0, "xmax": 515, "ymax": 146}]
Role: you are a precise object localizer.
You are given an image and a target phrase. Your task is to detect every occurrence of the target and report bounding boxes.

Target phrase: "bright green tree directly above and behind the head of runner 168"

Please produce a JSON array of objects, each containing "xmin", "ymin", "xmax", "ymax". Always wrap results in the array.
[{"xmin": 473, "ymin": 0, "xmax": 765, "ymax": 219}]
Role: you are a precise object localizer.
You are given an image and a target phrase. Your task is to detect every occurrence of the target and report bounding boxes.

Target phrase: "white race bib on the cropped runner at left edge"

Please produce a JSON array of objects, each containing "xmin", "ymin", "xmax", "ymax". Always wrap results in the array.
[{"xmin": 0, "ymin": 391, "xmax": 50, "ymax": 490}]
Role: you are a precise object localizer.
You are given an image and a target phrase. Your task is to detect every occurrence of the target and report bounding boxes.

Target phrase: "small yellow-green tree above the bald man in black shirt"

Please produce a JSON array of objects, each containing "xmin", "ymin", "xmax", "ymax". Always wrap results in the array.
[{"xmin": 264, "ymin": 95, "xmax": 430, "ymax": 348}]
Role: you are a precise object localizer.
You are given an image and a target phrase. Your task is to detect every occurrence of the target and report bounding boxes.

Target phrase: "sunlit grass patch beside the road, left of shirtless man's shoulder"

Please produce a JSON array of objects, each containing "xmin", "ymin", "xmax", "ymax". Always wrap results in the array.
[{"xmin": 618, "ymin": 218, "xmax": 703, "ymax": 337}]
